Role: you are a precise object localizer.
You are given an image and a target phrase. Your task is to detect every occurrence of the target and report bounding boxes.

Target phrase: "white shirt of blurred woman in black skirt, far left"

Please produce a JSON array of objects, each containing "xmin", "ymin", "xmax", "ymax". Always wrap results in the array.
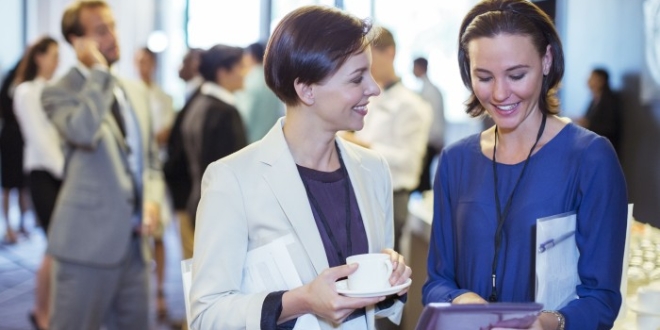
[{"xmin": 14, "ymin": 77, "xmax": 64, "ymax": 179}]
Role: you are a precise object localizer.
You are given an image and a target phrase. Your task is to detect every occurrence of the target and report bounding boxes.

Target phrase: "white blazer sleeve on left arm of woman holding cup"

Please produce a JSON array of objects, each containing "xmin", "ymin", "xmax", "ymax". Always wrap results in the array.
[{"xmin": 189, "ymin": 162, "xmax": 268, "ymax": 330}]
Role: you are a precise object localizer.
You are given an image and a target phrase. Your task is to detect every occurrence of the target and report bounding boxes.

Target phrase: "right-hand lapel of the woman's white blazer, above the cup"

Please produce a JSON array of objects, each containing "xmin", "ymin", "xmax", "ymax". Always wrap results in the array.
[{"xmin": 335, "ymin": 137, "xmax": 383, "ymax": 252}]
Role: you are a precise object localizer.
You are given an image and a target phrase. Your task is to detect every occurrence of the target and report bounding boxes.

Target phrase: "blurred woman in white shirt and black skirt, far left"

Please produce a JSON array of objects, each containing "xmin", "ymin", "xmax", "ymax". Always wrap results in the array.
[{"xmin": 14, "ymin": 36, "xmax": 64, "ymax": 329}]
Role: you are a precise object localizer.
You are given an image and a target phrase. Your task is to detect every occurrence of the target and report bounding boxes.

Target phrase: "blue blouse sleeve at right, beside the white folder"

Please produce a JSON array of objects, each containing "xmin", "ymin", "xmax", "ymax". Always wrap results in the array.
[{"xmin": 560, "ymin": 137, "xmax": 628, "ymax": 330}]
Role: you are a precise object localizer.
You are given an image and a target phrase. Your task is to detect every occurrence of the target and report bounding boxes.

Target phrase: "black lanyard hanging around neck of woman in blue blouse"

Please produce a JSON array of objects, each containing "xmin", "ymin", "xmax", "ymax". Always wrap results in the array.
[{"xmin": 488, "ymin": 115, "xmax": 547, "ymax": 302}]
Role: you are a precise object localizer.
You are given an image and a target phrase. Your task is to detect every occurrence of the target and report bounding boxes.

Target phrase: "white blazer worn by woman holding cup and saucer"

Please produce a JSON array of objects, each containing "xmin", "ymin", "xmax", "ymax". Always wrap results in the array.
[{"xmin": 190, "ymin": 118, "xmax": 403, "ymax": 329}]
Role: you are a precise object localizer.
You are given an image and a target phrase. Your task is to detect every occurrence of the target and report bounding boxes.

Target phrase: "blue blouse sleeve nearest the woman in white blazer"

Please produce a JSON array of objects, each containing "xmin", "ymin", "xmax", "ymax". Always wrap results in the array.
[{"xmin": 422, "ymin": 151, "xmax": 468, "ymax": 305}]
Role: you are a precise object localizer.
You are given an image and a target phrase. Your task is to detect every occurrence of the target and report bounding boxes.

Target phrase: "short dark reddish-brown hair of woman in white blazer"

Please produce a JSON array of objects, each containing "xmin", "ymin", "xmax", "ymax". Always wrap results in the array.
[{"xmin": 264, "ymin": 6, "xmax": 376, "ymax": 105}]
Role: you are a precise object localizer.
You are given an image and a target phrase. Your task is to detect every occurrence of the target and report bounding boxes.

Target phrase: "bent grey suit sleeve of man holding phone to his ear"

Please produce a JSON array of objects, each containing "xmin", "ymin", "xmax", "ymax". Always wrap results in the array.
[{"xmin": 41, "ymin": 69, "xmax": 115, "ymax": 149}]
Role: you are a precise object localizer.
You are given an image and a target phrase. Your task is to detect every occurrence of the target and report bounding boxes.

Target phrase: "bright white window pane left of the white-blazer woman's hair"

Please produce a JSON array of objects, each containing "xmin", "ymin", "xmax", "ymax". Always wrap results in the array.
[{"xmin": 188, "ymin": 0, "xmax": 261, "ymax": 48}]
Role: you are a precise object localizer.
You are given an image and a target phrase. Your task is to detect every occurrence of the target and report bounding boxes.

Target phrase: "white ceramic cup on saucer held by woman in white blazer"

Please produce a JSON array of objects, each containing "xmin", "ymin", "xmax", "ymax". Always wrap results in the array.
[{"xmin": 346, "ymin": 253, "xmax": 393, "ymax": 292}]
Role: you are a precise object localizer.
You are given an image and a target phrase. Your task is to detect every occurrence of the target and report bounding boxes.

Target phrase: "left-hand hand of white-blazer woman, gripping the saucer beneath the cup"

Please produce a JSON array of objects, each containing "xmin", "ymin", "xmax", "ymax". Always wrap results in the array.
[{"xmin": 280, "ymin": 264, "xmax": 385, "ymax": 324}]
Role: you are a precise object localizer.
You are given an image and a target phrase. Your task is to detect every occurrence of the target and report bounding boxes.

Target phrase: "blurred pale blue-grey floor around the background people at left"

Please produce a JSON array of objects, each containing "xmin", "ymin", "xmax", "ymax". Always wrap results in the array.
[{"xmin": 0, "ymin": 201, "xmax": 185, "ymax": 330}]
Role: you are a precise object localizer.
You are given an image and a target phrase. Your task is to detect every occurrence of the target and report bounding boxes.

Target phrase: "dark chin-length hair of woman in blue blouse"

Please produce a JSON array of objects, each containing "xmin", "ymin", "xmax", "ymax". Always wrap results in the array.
[{"xmin": 458, "ymin": 0, "xmax": 564, "ymax": 117}]
